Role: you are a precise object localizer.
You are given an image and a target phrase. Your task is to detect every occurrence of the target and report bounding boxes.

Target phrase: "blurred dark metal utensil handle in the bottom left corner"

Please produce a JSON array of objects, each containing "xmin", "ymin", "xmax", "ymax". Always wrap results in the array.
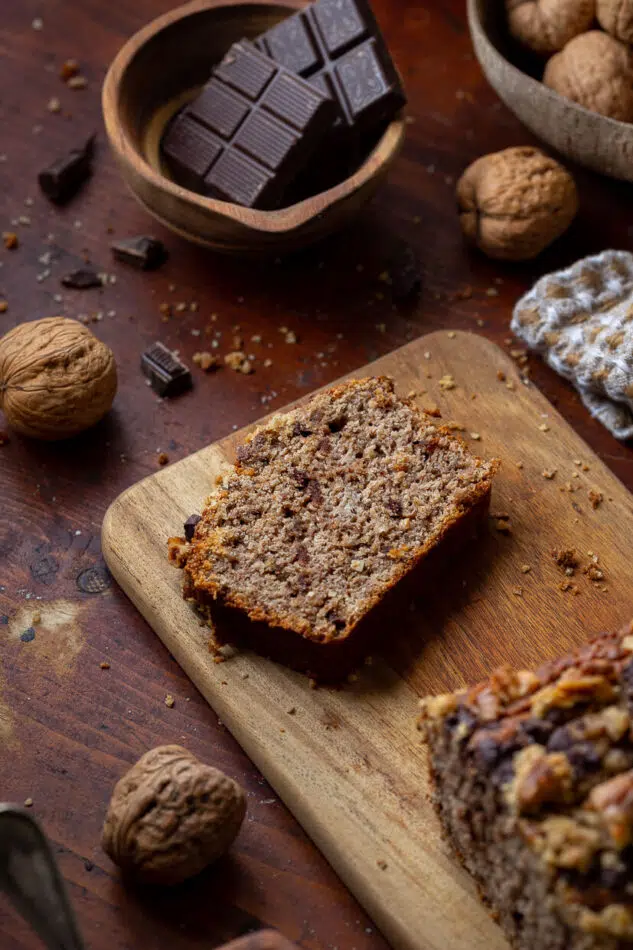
[{"xmin": 0, "ymin": 804, "xmax": 84, "ymax": 950}]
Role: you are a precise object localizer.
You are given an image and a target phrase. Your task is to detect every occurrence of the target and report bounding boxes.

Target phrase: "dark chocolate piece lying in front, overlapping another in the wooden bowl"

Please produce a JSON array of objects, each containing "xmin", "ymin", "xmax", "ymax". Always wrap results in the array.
[{"xmin": 162, "ymin": 40, "xmax": 336, "ymax": 209}]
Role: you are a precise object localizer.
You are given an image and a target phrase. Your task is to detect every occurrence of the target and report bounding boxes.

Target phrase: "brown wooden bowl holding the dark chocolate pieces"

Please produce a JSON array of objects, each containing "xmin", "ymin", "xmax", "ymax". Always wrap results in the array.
[{"xmin": 102, "ymin": 0, "xmax": 405, "ymax": 254}]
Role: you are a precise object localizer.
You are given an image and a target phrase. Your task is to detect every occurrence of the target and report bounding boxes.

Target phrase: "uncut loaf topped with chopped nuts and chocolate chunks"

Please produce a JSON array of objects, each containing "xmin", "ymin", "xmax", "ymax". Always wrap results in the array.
[{"xmin": 420, "ymin": 624, "xmax": 633, "ymax": 950}]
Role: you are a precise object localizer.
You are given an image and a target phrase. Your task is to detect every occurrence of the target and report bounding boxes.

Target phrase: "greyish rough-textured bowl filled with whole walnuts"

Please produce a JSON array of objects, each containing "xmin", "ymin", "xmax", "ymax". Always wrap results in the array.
[{"xmin": 468, "ymin": 0, "xmax": 633, "ymax": 181}]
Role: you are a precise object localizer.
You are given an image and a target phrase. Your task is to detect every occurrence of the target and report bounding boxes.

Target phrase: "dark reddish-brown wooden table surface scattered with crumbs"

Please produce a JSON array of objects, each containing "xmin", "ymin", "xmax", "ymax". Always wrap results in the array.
[{"xmin": 0, "ymin": 0, "xmax": 633, "ymax": 950}]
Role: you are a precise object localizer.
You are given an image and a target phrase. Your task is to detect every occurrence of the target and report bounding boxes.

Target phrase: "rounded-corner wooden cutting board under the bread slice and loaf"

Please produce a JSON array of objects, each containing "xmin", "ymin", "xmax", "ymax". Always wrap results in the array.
[{"xmin": 103, "ymin": 332, "xmax": 633, "ymax": 950}]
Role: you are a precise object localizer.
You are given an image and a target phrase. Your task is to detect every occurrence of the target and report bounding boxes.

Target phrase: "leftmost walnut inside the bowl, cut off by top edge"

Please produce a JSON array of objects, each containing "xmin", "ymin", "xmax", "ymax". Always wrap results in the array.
[{"xmin": 506, "ymin": 0, "xmax": 596, "ymax": 54}]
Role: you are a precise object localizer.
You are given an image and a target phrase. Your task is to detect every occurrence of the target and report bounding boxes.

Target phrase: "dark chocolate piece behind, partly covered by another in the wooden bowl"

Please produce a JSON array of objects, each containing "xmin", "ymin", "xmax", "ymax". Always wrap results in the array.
[{"xmin": 255, "ymin": 0, "xmax": 406, "ymax": 138}]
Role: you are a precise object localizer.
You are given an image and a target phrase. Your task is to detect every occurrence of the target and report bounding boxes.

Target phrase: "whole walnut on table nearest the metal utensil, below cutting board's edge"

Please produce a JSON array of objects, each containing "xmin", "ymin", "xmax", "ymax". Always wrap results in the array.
[{"xmin": 101, "ymin": 745, "xmax": 246, "ymax": 884}]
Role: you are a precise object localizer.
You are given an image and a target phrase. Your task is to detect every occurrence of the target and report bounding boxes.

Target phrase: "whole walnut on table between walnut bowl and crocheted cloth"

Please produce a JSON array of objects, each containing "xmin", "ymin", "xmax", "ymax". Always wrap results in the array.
[{"xmin": 457, "ymin": 146, "xmax": 578, "ymax": 261}]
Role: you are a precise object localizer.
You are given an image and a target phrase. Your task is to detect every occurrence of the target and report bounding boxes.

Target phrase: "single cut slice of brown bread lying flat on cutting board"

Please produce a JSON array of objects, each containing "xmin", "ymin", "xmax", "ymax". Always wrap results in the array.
[{"xmin": 170, "ymin": 378, "xmax": 495, "ymax": 680}]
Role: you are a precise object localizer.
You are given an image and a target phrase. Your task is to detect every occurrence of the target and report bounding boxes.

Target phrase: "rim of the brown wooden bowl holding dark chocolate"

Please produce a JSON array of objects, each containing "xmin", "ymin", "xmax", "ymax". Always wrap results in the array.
[{"xmin": 101, "ymin": 0, "xmax": 406, "ymax": 234}]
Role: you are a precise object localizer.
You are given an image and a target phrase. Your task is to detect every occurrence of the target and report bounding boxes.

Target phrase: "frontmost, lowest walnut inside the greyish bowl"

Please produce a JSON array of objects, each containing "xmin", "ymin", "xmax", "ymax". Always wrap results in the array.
[{"xmin": 543, "ymin": 30, "xmax": 633, "ymax": 122}]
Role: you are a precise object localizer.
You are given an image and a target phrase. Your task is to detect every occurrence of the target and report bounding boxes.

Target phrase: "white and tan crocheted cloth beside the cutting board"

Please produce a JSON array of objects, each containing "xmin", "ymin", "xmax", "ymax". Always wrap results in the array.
[{"xmin": 511, "ymin": 251, "xmax": 633, "ymax": 439}]
